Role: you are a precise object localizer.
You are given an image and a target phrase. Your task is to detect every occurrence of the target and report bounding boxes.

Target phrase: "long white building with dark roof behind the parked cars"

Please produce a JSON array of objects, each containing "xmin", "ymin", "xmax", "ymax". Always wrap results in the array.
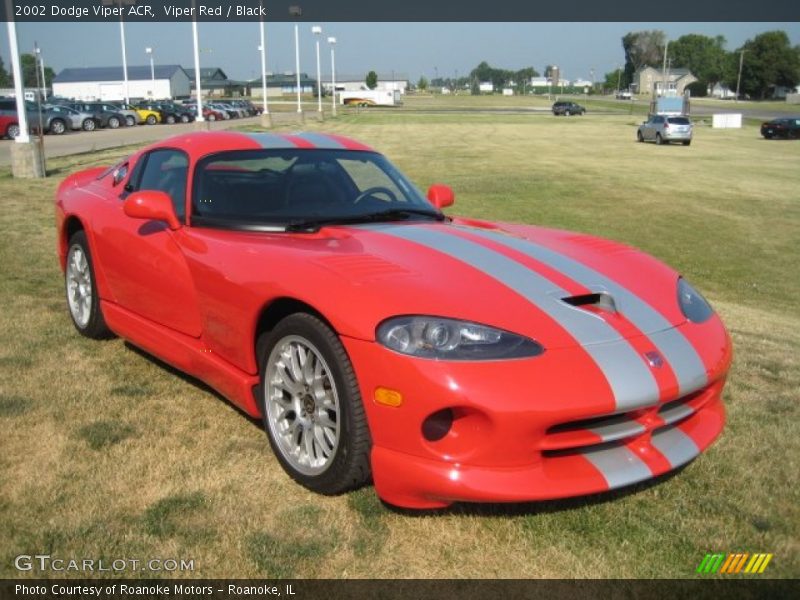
[{"xmin": 53, "ymin": 65, "xmax": 190, "ymax": 101}]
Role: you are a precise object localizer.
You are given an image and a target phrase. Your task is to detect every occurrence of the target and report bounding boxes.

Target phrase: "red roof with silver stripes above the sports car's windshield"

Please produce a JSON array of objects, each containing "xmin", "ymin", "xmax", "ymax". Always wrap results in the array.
[{"xmin": 147, "ymin": 131, "xmax": 374, "ymax": 158}]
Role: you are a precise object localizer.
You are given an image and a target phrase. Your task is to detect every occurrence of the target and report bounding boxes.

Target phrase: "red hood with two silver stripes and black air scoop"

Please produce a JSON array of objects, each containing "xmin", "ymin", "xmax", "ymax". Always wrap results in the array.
[{"xmin": 214, "ymin": 219, "xmax": 686, "ymax": 348}]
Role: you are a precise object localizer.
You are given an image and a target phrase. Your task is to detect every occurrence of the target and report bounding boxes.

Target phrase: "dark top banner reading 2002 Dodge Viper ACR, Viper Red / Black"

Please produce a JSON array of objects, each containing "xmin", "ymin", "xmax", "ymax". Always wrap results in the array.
[{"xmin": 0, "ymin": 0, "xmax": 800, "ymax": 22}]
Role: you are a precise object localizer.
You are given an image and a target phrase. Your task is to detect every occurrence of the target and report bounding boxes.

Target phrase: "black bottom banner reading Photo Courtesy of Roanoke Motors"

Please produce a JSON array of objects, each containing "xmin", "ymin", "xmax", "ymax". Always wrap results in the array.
[{"xmin": 0, "ymin": 577, "xmax": 800, "ymax": 600}]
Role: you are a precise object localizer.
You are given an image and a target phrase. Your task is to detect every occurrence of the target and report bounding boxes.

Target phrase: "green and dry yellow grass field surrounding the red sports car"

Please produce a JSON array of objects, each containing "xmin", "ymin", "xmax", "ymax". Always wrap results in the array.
[{"xmin": 0, "ymin": 105, "xmax": 800, "ymax": 578}]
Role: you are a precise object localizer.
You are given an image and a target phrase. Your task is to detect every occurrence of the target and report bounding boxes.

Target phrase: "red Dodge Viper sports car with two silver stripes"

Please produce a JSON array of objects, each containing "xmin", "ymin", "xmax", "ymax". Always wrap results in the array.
[{"xmin": 56, "ymin": 132, "xmax": 731, "ymax": 508}]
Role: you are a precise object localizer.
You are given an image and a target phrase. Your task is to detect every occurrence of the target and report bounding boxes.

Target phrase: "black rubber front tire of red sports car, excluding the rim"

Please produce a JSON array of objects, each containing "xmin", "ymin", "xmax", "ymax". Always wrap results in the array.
[{"xmin": 258, "ymin": 313, "xmax": 369, "ymax": 495}]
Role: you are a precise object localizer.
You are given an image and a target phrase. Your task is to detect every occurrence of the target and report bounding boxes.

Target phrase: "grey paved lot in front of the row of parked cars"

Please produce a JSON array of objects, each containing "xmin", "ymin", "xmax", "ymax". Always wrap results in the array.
[{"xmin": 0, "ymin": 117, "xmax": 260, "ymax": 166}]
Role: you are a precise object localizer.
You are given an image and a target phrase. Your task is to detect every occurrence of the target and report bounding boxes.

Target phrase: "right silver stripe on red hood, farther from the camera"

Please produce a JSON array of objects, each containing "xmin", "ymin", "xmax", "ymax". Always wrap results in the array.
[{"xmin": 459, "ymin": 227, "xmax": 708, "ymax": 396}]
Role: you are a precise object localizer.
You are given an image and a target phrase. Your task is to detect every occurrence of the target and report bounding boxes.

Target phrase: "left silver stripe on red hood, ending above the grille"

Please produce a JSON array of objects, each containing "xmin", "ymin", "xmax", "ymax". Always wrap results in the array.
[{"xmin": 376, "ymin": 225, "xmax": 659, "ymax": 411}]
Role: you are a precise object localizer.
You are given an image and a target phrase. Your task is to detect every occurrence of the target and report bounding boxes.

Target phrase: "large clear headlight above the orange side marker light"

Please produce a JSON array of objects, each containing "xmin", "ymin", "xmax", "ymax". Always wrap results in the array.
[{"xmin": 377, "ymin": 316, "xmax": 544, "ymax": 360}]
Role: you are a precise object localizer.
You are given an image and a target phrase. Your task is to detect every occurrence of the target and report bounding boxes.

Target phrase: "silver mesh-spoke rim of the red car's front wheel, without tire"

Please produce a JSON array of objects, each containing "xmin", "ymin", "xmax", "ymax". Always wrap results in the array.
[{"xmin": 264, "ymin": 335, "xmax": 339, "ymax": 476}]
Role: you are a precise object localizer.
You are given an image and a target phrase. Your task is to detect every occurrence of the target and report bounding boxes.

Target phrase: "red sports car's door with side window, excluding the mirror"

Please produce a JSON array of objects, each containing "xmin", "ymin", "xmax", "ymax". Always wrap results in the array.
[{"xmin": 92, "ymin": 148, "xmax": 201, "ymax": 337}]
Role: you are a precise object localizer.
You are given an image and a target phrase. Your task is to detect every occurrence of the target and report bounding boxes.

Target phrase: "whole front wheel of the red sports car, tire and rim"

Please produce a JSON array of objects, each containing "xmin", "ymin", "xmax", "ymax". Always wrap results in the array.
[{"xmin": 258, "ymin": 313, "xmax": 371, "ymax": 495}]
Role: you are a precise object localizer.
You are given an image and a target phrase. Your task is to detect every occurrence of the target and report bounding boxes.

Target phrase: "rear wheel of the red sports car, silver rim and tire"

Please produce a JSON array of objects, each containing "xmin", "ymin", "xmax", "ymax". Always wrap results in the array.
[{"xmin": 64, "ymin": 231, "xmax": 110, "ymax": 339}]
